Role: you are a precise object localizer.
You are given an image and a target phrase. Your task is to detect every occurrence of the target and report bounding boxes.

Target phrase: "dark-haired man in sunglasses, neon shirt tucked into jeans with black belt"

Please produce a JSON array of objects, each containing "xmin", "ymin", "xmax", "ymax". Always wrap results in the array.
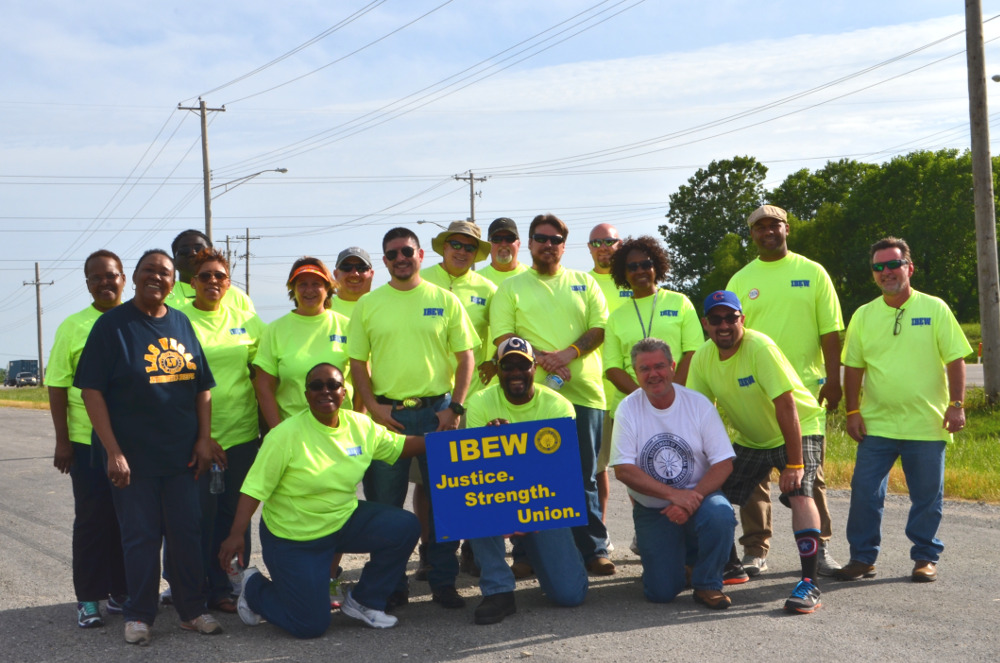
[{"xmin": 347, "ymin": 228, "xmax": 480, "ymax": 608}]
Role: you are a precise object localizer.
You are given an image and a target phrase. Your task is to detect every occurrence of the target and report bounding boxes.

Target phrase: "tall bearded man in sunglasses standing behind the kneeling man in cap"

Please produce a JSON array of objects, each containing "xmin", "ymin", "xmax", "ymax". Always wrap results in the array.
[{"xmin": 490, "ymin": 214, "xmax": 615, "ymax": 577}]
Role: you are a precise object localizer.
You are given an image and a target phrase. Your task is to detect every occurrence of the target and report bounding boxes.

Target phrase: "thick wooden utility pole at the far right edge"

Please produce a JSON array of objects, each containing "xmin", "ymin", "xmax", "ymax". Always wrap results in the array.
[{"xmin": 965, "ymin": 0, "xmax": 1000, "ymax": 404}]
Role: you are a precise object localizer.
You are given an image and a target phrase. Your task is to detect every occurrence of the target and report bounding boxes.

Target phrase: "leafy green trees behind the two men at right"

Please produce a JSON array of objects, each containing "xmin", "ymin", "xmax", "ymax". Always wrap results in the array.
[{"xmin": 659, "ymin": 150, "xmax": 1000, "ymax": 322}]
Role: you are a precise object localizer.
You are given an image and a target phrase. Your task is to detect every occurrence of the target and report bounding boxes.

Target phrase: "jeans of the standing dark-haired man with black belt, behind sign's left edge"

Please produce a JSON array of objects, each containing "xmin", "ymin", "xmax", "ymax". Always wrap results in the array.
[{"xmin": 363, "ymin": 396, "xmax": 459, "ymax": 590}]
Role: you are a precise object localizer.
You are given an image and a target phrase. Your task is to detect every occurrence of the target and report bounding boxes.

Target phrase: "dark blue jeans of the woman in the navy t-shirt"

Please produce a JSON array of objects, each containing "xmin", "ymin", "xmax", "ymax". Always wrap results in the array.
[{"xmin": 111, "ymin": 472, "xmax": 205, "ymax": 624}]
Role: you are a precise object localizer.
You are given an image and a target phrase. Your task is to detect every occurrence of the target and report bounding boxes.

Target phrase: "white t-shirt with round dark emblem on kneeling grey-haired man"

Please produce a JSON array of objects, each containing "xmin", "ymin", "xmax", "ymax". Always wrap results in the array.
[{"xmin": 610, "ymin": 384, "xmax": 736, "ymax": 509}]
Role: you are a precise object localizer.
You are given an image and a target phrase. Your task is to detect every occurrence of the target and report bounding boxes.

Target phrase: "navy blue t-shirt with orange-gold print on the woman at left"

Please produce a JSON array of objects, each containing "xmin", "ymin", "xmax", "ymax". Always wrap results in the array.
[{"xmin": 73, "ymin": 301, "xmax": 215, "ymax": 476}]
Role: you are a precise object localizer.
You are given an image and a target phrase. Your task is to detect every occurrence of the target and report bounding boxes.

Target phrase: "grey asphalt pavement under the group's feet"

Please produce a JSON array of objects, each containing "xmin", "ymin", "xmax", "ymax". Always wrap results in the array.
[{"xmin": 0, "ymin": 409, "xmax": 1000, "ymax": 663}]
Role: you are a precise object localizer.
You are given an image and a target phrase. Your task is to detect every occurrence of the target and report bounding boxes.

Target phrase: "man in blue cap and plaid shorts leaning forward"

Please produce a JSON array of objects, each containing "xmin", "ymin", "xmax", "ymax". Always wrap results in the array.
[{"xmin": 687, "ymin": 290, "xmax": 824, "ymax": 613}]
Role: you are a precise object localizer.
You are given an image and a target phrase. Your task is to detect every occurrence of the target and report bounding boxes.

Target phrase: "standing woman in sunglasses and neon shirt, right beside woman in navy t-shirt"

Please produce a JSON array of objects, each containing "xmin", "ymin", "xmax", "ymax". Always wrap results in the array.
[{"xmin": 180, "ymin": 248, "xmax": 264, "ymax": 613}]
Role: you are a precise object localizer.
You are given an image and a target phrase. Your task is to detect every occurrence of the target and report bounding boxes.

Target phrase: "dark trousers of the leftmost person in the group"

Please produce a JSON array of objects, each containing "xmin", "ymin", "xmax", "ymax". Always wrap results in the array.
[{"xmin": 69, "ymin": 442, "xmax": 127, "ymax": 601}]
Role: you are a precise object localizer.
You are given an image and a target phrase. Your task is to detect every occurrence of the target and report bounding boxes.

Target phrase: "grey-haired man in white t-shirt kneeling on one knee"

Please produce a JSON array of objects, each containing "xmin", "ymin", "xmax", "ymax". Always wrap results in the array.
[{"xmin": 611, "ymin": 338, "xmax": 736, "ymax": 610}]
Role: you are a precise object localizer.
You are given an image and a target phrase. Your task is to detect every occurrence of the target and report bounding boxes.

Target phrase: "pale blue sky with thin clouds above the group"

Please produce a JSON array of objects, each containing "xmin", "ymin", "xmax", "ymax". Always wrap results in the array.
[{"xmin": 0, "ymin": 0, "xmax": 1000, "ymax": 364}]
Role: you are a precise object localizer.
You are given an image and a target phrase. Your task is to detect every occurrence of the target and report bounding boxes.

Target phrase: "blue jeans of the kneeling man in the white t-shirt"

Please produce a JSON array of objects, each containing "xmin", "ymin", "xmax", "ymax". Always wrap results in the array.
[{"xmin": 632, "ymin": 491, "xmax": 736, "ymax": 603}]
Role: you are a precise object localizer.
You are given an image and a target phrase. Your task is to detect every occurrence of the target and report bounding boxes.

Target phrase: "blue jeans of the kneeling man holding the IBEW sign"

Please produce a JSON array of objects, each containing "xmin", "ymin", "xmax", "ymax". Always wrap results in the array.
[{"xmin": 469, "ymin": 527, "xmax": 588, "ymax": 606}]
